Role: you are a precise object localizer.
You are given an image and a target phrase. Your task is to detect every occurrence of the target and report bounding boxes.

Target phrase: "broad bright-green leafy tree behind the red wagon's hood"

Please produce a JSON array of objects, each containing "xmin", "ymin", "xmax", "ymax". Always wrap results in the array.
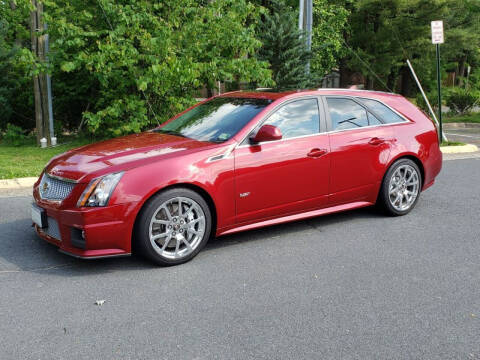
[{"xmin": 24, "ymin": 0, "xmax": 270, "ymax": 136}]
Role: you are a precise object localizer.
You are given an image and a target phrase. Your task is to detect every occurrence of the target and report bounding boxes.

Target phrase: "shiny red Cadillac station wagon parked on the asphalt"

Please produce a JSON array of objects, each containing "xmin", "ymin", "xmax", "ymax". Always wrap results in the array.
[{"xmin": 32, "ymin": 89, "xmax": 442, "ymax": 265}]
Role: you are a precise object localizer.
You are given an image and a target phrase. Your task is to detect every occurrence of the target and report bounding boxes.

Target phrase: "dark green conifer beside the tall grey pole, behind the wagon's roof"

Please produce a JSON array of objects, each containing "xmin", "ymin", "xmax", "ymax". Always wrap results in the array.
[{"xmin": 257, "ymin": 0, "xmax": 316, "ymax": 89}]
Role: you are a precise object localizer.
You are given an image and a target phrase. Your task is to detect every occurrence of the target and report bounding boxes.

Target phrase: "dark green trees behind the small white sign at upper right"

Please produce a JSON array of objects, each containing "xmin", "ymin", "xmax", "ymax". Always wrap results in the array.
[{"xmin": 343, "ymin": 0, "xmax": 480, "ymax": 95}]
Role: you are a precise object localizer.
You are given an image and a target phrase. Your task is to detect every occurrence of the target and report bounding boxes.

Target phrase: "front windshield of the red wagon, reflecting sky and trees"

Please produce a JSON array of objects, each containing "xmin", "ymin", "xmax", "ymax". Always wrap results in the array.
[{"xmin": 154, "ymin": 97, "xmax": 272, "ymax": 142}]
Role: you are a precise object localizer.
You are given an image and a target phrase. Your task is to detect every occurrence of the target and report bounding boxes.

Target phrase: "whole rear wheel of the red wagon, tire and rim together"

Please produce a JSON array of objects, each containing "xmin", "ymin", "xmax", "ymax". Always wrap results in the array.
[{"xmin": 378, "ymin": 159, "xmax": 422, "ymax": 216}]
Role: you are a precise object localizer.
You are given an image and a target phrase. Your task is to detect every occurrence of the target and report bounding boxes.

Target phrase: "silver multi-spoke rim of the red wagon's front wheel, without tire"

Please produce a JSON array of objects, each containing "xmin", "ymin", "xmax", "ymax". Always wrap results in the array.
[{"xmin": 149, "ymin": 197, "xmax": 205, "ymax": 259}]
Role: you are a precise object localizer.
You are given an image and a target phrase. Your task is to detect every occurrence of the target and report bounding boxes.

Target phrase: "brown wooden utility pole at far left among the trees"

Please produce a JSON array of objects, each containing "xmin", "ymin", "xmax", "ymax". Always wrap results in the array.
[{"xmin": 30, "ymin": 0, "xmax": 53, "ymax": 145}]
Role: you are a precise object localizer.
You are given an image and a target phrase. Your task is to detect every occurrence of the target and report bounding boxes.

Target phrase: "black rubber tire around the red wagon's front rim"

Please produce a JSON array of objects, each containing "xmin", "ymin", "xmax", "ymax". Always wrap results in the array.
[{"xmin": 134, "ymin": 188, "xmax": 212, "ymax": 266}]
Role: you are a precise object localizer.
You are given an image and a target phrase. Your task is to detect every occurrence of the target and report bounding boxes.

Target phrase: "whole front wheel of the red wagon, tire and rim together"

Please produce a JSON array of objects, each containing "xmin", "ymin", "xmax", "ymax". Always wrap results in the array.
[{"xmin": 135, "ymin": 188, "xmax": 212, "ymax": 266}]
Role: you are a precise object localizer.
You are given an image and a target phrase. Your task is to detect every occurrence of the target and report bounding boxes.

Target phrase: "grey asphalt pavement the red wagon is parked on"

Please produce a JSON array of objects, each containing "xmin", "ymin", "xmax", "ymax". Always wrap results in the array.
[{"xmin": 0, "ymin": 159, "xmax": 480, "ymax": 360}]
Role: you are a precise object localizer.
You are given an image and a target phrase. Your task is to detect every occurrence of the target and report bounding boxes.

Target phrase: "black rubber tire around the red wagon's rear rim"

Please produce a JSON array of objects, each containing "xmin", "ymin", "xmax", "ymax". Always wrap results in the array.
[{"xmin": 377, "ymin": 159, "xmax": 423, "ymax": 216}]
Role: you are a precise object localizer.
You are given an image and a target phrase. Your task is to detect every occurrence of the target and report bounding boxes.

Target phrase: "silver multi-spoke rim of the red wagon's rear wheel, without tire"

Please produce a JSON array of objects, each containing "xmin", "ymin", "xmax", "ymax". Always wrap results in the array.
[{"xmin": 388, "ymin": 165, "xmax": 420, "ymax": 211}]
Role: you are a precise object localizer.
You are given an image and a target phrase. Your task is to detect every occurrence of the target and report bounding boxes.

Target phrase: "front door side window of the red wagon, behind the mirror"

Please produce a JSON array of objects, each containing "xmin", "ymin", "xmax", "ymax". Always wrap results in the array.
[{"xmin": 264, "ymin": 99, "xmax": 320, "ymax": 139}]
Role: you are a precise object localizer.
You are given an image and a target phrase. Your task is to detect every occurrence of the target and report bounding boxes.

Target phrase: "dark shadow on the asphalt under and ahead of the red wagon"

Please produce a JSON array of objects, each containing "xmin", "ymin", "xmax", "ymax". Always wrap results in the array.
[{"xmin": 0, "ymin": 208, "xmax": 383, "ymax": 277}]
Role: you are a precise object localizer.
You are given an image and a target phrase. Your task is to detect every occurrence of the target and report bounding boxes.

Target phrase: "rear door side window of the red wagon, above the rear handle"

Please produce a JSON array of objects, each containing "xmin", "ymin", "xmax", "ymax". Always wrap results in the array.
[{"xmin": 327, "ymin": 98, "xmax": 368, "ymax": 130}]
